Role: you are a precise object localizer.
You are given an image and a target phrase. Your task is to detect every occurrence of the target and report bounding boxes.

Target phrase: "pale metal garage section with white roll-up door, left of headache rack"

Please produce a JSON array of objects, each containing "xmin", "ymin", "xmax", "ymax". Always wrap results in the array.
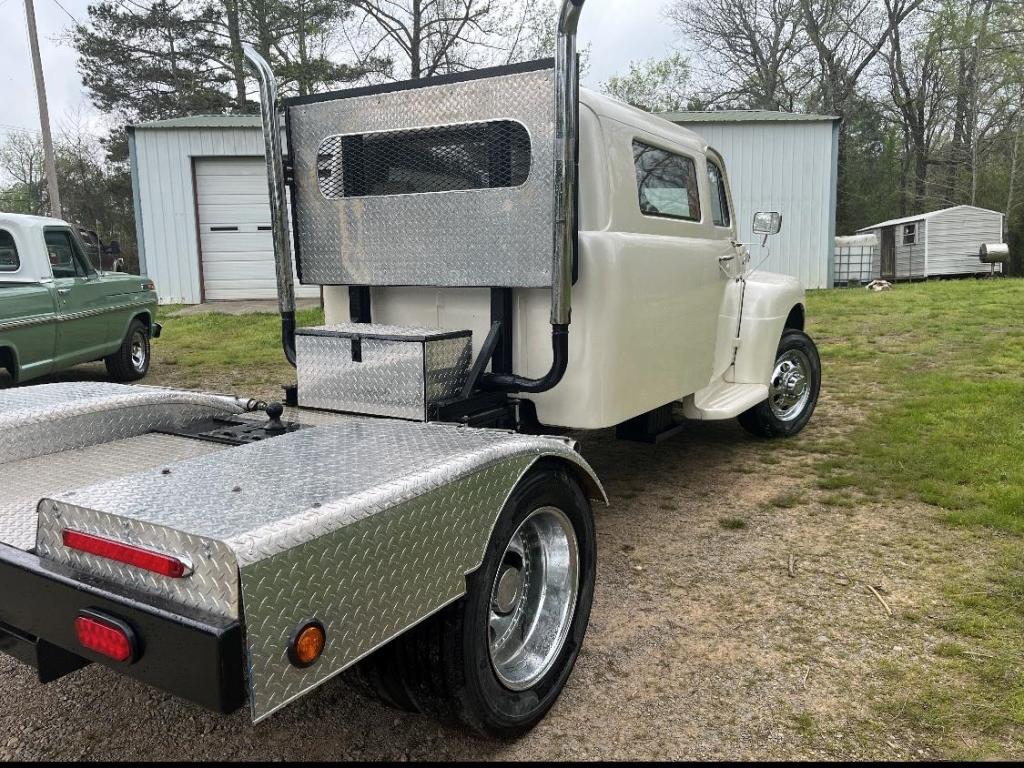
[{"xmin": 129, "ymin": 115, "xmax": 319, "ymax": 304}]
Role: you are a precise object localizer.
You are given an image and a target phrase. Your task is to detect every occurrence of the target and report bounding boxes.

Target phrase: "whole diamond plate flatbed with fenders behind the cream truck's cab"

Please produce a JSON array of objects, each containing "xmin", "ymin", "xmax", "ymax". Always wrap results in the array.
[{"xmin": 0, "ymin": 385, "xmax": 604, "ymax": 720}]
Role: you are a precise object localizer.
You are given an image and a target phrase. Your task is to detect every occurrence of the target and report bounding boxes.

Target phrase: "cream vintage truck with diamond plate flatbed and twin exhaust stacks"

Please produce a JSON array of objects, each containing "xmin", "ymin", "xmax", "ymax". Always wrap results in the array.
[{"xmin": 0, "ymin": 0, "xmax": 821, "ymax": 737}]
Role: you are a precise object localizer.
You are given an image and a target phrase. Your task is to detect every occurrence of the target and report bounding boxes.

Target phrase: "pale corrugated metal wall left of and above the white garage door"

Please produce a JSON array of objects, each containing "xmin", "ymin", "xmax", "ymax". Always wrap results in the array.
[{"xmin": 135, "ymin": 128, "xmax": 263, "ymax": 304}]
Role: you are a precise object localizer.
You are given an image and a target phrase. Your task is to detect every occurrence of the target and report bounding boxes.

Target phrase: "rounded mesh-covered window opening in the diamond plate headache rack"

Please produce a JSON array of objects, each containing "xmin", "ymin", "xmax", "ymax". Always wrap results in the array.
[{"xmin": 316, "ymin": 120, "xmax": 532, "ymax": 200}]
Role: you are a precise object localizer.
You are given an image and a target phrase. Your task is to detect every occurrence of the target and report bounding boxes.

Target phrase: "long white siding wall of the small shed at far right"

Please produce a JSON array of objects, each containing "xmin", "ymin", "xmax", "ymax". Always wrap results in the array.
[{"xmin": 928, "ymin": 206, "xmax": 1002, "ymax": 278}]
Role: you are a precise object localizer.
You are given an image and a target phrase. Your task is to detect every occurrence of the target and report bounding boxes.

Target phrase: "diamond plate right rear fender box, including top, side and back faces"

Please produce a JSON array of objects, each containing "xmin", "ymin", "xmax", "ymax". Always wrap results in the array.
[{"xmin": 29, "ymin": 417, "xmax": 603, "ymax": 719}]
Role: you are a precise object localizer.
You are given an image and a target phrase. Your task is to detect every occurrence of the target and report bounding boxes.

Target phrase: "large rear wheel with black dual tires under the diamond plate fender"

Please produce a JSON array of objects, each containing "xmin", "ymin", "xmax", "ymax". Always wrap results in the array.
[{"xmin": 347, "ymin": 463, "xmax": 597, "ymax": 738}]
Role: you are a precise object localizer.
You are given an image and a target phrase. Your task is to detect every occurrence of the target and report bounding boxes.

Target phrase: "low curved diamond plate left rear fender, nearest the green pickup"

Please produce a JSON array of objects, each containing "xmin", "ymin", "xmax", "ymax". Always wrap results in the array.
[{"xmin": 0, "ymin": 382, "xmax": 251, "ymax": 464}]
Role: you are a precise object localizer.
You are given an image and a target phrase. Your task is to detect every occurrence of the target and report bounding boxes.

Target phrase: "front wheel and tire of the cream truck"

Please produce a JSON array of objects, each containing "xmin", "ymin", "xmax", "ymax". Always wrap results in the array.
[{"xmin": 738, "ymin": 329, "xmax": 821, "ymax": 437}]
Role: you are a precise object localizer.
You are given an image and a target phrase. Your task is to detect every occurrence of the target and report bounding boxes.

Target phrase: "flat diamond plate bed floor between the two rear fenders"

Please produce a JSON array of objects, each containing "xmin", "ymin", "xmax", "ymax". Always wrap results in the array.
[{"xmin": 0, "ymin": 434, "xmax": 226, "ymax": 550}]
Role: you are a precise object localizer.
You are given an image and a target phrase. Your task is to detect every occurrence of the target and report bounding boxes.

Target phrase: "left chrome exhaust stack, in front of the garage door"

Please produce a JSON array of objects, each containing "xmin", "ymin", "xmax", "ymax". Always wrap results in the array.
[{"xmin": 242, "ymin": 43, "xmax": 295, "ymax": 368}]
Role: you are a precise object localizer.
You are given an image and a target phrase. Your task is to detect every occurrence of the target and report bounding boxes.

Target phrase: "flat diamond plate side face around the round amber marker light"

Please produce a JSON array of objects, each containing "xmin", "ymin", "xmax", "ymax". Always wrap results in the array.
[{"xmin": 242, "ymin": 457, "xmax": 534, "ymax": 721}]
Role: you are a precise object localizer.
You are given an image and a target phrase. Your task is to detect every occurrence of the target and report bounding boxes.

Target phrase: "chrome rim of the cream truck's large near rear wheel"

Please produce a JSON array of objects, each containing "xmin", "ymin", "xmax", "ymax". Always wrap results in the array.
[{"xmin": 488, "ymin": 507, "xmax": 580, "ymax": 691}]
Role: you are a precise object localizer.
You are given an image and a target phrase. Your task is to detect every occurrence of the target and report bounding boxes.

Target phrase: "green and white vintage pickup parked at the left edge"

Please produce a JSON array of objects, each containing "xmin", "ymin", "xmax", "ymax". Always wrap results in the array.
[{"xmin": 0, "ymin": 213, "xmax": 160, "ymax": 382}]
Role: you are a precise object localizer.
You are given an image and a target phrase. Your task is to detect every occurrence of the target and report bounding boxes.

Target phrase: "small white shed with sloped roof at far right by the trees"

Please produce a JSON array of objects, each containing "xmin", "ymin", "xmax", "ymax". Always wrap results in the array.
[{"xmin": 859, "ymin": 206, "xmax": 1002, "ymax": 281}]
